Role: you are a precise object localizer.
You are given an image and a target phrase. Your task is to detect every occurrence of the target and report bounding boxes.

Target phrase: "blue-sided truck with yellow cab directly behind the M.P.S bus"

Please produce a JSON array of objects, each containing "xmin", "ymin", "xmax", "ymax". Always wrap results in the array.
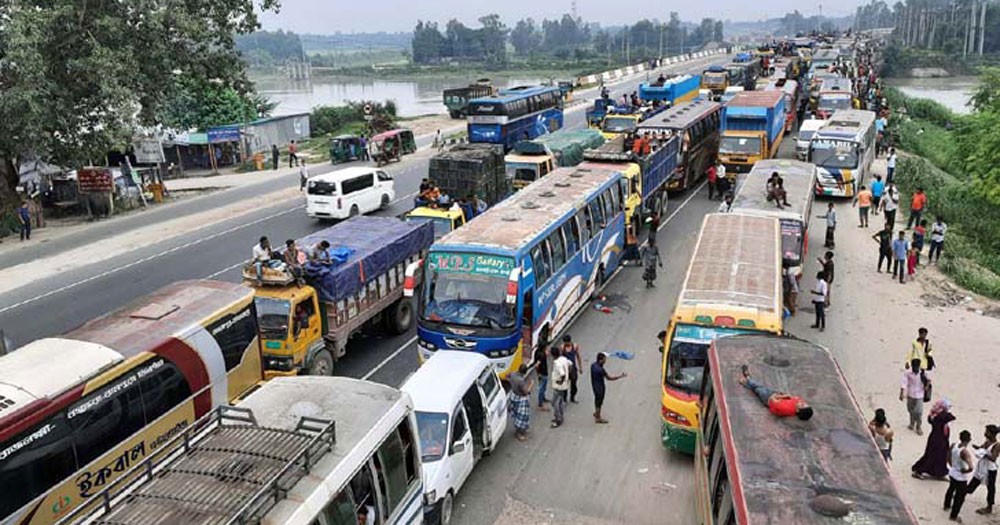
[{"xmin": 580, "ymin": 132, "xmax": 681, "ymax": 228}]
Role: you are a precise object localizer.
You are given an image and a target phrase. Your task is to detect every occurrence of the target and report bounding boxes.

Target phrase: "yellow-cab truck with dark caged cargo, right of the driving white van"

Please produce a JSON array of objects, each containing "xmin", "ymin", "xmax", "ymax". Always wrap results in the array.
[{"xmin": 404, "ymin": 144, "xmax": 511, "ymax": 239}]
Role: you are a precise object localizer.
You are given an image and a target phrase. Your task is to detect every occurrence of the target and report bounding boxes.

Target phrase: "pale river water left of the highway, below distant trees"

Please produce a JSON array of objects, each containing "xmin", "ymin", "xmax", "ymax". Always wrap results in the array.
[{"xmin": 255, "ymin": 77, "xmax": 542, "ymax": 117}]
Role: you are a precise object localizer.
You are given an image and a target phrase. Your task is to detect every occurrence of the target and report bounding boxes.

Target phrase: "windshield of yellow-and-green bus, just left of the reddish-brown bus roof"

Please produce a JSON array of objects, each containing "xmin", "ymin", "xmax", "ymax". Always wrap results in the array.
[{"xmin": 663, "ymin": 324, "xmax": 753, "ymax": 394}]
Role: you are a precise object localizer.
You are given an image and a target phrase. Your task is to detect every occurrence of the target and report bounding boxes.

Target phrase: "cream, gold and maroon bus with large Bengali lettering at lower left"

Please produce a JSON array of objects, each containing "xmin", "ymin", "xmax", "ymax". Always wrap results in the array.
[{"xmin": 0, "ymin": 281, "xmax": 263, "ymax": 525}]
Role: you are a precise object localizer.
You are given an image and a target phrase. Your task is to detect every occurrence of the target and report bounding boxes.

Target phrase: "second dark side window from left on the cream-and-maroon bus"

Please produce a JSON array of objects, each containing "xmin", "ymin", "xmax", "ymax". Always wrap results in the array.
[{"xmin": 67, "ymin": 372, "xmax": 146, "ymax": 466}]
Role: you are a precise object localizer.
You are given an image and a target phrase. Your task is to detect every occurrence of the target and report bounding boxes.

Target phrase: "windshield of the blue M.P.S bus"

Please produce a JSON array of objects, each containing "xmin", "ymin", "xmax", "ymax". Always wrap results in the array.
[{"xmin": 421, "ymin": 253, "xmax": 515, "ymax": 330}]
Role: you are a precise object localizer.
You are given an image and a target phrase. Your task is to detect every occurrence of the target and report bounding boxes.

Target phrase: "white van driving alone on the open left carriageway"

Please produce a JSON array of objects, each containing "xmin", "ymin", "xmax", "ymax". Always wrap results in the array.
[{"xmin": 306, "ymin": 167, "xmax": 396, "ymax": 219}]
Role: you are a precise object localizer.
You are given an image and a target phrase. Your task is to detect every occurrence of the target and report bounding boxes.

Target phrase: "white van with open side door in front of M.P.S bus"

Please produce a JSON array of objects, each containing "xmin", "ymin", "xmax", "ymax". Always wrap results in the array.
[{"xmin": 400, "ymin": 350, "xmax": 507, "ymax": 525}]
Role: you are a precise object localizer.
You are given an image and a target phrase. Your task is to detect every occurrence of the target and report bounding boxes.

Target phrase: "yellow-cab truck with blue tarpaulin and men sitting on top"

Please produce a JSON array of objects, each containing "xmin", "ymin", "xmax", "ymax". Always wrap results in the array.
[{"xmin": 243, "ymin": 216, "xmax": 434, "ymax": 379}]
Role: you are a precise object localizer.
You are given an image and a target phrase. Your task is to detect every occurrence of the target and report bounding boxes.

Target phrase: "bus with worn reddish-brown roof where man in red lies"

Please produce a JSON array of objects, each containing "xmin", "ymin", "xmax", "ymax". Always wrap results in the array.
[{"xmin": 694, "ymin": 334, "xmax": 919, "ymax": 525}]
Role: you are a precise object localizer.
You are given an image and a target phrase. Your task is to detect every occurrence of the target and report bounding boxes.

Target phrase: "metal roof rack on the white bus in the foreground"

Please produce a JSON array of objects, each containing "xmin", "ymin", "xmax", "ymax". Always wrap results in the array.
[{"xmin": 60, "ymin": 405, "xmax": 336, "ymax": 525}]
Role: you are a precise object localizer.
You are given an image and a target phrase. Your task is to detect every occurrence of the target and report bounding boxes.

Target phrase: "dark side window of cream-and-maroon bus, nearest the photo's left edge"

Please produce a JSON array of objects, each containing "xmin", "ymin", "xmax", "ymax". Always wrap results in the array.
[{"xmin": 0, "ymin": 412, "xmax": 76, "ymax": 516}]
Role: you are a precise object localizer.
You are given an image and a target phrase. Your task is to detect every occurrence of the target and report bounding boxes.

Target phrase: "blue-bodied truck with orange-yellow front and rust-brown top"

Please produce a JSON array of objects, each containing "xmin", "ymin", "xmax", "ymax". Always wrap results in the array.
[{"xmin": 719, "ymin": 91, "xmax": 785, "ymax": 173}]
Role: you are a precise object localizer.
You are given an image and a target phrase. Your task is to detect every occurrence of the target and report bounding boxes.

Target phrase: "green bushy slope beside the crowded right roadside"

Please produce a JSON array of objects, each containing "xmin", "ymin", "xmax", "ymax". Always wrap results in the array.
[{"xmin": 886, "ymin": 89, "xmax": 1000, "ymax": 299}]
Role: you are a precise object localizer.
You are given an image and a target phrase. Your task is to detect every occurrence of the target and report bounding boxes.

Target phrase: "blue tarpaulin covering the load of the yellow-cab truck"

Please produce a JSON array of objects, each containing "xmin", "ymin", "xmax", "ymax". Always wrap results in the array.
[{"xmin": 298, "ymin": 216, "xmax": 434, "ymax": 302}]
